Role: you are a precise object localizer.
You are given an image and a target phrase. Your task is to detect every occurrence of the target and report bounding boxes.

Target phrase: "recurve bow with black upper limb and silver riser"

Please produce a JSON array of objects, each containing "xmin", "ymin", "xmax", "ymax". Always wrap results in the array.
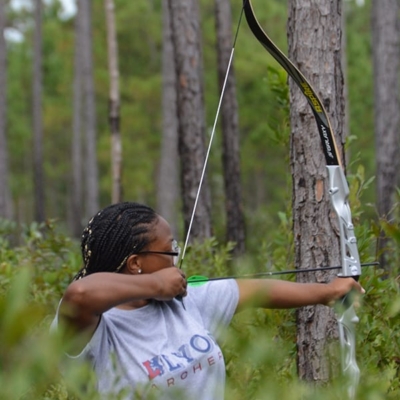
[{"xmin": 243, "ymin": 0, "xmax": 361, "ymax": 399}]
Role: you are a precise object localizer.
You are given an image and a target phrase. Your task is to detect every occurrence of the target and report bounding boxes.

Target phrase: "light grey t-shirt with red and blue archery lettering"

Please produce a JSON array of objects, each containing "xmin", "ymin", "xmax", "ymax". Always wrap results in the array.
[{"xmin": 55, "ymin": 280, "xmax": 239, "ymax": 400}]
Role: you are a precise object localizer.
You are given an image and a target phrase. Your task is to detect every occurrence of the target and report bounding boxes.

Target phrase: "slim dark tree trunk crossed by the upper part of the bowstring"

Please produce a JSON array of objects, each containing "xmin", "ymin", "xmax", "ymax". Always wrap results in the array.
[{"xmin": 215, "ymin": 0, "xmax": 245, "ymax": 255}]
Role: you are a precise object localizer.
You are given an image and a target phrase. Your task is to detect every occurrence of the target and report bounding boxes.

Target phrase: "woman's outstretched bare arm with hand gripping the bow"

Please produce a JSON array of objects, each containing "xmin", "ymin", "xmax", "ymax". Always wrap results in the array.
[{"xmin": 236, "ymin": 278, "xmax": 364, "ymax": 312}]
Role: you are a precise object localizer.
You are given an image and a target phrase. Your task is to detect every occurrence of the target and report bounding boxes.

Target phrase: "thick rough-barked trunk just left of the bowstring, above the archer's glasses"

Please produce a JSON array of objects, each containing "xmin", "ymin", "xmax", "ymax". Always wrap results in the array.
[{"xmin": 168, "ymin": 0, "xmax": 212, "ymax": 239}]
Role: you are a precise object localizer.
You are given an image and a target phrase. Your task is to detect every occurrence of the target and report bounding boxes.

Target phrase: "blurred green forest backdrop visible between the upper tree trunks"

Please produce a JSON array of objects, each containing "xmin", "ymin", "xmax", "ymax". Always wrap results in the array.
[{"xmin": 3, "ymin": 1, "xmax": 376, "ymax": 236}]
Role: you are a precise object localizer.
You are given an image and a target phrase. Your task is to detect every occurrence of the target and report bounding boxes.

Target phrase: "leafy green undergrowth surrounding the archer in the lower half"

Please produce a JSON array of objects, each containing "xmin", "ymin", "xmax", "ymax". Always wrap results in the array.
[{"xmin": 0, "ymin": 218, "xmax": 400, "ymax": 400}]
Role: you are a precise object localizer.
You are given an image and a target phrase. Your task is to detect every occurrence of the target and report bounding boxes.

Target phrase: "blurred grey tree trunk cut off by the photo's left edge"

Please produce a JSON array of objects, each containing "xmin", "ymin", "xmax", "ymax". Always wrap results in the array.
[{"xmin": 0, "ymin": 0, "xmax": 13, "ymax": 219}]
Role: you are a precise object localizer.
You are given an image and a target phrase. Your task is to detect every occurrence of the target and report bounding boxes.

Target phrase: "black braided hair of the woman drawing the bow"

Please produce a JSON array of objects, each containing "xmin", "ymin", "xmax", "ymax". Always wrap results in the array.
[{"xmin": 74, "ymin": 202, "xmax": 158, "ymax": 281}]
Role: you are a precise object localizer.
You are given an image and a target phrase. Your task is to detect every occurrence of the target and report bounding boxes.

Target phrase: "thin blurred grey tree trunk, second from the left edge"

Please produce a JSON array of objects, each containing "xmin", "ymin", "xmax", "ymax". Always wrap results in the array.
[{"xmin": 32, "ymin": 0, "xmax": 45, "ymax": 222}]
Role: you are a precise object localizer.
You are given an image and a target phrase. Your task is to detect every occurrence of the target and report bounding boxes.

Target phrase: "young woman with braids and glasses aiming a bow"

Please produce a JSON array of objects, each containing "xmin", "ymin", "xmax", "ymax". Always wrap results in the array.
[{"xmin": 56, "ymin": 202, "xmax": 362, "ymax": 399}]
